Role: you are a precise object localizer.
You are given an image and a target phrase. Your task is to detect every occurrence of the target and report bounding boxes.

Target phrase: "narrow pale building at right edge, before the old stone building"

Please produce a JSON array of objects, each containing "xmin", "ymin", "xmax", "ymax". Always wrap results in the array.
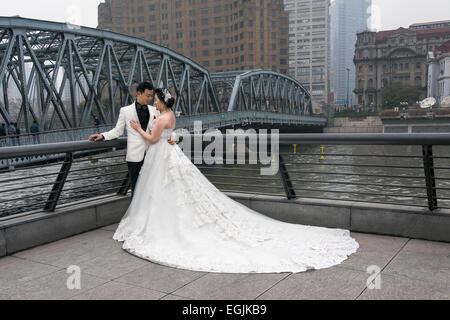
[{"xmin": 428, "ymin": 41, "xmax": 450, "ymax": 103}]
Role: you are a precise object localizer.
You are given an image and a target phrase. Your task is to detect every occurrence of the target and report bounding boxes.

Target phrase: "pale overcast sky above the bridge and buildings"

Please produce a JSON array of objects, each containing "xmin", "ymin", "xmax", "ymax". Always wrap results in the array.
[{"xmin": 0, "ymin": 0, "xmax": 450, "ymax": 30}]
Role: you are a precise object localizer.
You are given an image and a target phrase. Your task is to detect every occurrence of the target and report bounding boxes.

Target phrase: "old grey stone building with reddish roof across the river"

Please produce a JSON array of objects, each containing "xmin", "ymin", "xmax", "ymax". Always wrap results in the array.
[{"xmin": 354, "ymin": 23, "xmax": 450, "ymax": 111}]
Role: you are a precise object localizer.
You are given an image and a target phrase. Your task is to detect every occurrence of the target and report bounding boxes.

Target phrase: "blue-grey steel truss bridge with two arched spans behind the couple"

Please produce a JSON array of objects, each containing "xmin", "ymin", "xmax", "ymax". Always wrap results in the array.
[{"xmin": 0, "ymin": 17, "xmax": 326, "ymax": 132}]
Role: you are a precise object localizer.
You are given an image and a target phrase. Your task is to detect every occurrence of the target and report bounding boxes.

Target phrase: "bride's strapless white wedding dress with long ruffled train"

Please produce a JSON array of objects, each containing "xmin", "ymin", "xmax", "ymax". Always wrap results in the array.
[{"xmin": 113, "ymin": 129, "xmax": 359, "ymax": 273}]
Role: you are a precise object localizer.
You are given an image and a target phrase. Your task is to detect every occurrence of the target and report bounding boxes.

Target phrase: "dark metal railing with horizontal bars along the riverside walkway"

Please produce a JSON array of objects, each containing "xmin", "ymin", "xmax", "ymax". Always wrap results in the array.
[{"xmin": 0, "ymin": 134, "xmax": 450, "ymax": 219}]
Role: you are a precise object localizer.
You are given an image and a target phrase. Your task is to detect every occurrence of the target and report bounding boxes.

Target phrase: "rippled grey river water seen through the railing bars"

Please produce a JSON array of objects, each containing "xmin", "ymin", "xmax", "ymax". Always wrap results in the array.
[{"xmin": 0, "ymin": 145, "xmax": 450, "ymax": 217}]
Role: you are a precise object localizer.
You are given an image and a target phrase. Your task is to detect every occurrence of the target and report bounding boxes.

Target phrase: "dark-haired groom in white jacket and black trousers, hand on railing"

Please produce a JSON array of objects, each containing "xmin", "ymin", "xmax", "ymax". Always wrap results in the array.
[{"xmin": 89, "ymin": 82, "xmax": 174, "ymax": 196}]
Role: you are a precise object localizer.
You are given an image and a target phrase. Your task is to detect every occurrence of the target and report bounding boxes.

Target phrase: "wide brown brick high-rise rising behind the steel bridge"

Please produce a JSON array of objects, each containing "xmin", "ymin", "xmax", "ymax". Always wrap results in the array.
[{"xmin": 98, "ymin": 0, "xmax": 289, "ymax": 74}]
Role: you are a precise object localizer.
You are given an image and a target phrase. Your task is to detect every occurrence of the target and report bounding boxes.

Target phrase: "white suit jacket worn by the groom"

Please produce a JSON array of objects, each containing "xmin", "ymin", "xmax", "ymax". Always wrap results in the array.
[{"xmin": 102, "ymin": 103, "xmax": 160, "ymax": 162}]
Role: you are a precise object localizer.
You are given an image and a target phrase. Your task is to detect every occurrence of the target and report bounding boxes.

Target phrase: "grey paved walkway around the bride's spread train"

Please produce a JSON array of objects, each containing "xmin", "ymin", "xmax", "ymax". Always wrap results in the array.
[{"xmin": 0, "ymin": 225, "xmax": 450, "ymax": 300}]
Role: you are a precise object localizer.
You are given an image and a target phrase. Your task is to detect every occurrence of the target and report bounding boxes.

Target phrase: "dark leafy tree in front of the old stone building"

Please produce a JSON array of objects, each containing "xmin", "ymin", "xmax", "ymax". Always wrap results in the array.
[{"xmin": 381, "ymin": 82, "xmax": 426, "ymax": 109}]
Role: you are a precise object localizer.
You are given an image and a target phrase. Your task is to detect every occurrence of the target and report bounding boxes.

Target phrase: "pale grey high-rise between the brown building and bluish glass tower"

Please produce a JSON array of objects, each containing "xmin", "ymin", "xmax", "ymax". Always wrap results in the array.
[{"xmin": 284, "ymin": 0, "xmax": 329, "ymax": 113}]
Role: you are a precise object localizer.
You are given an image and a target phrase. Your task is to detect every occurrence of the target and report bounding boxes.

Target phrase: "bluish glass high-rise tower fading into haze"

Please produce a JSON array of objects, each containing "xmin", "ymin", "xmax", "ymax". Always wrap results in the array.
[{"xmin": 330, "ymin": 0, "xmax": 372, "ymax": 106}]
